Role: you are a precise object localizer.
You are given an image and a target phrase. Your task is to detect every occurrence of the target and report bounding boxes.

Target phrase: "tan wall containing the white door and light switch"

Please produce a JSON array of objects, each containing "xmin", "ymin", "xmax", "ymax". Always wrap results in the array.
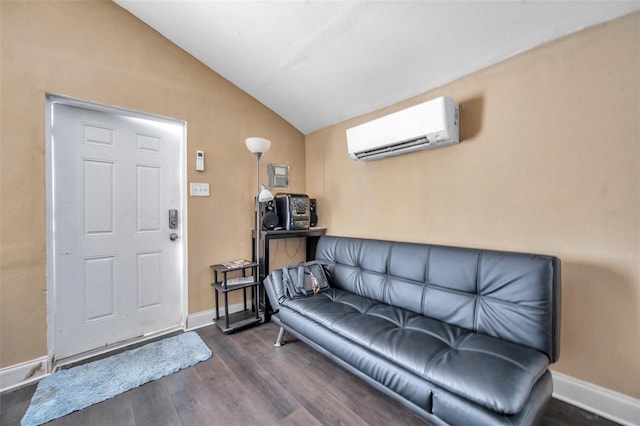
[{"xmin": 0, "ymin": 1, "xmax": 305, "ymax": 367}]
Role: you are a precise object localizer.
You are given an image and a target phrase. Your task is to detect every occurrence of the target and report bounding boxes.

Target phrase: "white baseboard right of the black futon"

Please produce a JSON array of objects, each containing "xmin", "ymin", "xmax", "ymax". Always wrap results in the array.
[{"xmin": 551, "ymin": 371, "xmax": 640, "ymax": 426}]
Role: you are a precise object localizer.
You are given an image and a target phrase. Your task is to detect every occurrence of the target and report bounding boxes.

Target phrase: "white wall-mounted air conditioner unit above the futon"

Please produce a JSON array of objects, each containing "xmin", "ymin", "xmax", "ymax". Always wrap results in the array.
[{"xmin": 347, "ymin": 96, "xmax": 459, "ymax": 161}]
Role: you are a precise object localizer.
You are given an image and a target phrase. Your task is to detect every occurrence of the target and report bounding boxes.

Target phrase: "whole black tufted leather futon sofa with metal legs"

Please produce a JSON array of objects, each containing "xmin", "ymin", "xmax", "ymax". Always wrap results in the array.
[{"xmin": 265, "ymin": 236, "xmax": 560, "ymax": 426}]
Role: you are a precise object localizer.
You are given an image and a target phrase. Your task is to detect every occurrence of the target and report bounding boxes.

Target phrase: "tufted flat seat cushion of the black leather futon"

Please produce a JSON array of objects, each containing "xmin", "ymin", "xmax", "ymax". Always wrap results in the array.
[{"xmin": 281, "ymin": 288, "xmax": 549, "ymax": 414}]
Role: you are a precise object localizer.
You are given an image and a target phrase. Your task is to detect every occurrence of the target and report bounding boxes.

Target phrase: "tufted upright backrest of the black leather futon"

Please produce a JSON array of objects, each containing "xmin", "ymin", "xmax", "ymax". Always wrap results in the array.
[{"xmin": 316, "ymin": 236, "xmax": 560, "ymax": 362}]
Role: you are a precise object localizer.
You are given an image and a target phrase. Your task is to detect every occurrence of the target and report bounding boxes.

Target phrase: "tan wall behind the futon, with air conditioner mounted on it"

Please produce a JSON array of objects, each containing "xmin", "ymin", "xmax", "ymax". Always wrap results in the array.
[{"xmin": 306, "ymin": 14, "xmax": 640, "ymax": 398}]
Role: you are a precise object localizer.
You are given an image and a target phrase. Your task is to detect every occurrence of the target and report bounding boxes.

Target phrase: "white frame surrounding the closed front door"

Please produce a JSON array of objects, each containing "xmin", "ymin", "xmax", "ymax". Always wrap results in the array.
[{"xmin": 44, "ymin": 93, "xmax": 189, "ymax": 373}]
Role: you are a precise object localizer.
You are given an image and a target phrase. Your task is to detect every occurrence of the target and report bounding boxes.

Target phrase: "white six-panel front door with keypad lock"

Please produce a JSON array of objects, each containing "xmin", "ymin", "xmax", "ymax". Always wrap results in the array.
[{"xmin": 49, "ymin": 103, "xmax": 184, "ymax": 359}]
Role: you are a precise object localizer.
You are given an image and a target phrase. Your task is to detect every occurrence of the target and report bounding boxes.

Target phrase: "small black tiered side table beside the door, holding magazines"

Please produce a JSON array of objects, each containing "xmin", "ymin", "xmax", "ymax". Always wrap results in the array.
[{"xmin": 211, "ymin": 262, "xmax": 262, "ymax": 333}]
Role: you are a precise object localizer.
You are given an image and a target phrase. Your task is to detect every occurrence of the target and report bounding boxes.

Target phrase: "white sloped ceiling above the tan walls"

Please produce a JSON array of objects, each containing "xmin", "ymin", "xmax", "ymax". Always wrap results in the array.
[{"xmin": 114, "ymin": 0, "xmax": 640, "ymax": 134}]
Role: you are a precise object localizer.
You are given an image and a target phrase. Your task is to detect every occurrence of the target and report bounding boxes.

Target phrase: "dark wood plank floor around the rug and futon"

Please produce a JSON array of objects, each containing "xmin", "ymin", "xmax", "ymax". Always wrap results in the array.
[{"xmin": 0, "ymin": 324, "xmax": 615, "ymax": 426}]
